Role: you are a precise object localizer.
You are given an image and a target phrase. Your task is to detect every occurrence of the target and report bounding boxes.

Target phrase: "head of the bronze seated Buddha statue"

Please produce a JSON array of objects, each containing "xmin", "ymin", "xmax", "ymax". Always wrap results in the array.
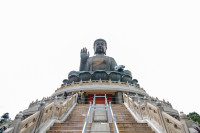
[{"xmin": 93, "ymin": 39, "xmax": 107, "ymax": 55}]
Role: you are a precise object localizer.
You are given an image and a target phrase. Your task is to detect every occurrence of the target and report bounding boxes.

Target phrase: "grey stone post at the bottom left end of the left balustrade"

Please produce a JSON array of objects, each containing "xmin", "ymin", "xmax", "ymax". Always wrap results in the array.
[{"xmin": 13, "ymin": 111, "xmax": 23, "ymax": 133}]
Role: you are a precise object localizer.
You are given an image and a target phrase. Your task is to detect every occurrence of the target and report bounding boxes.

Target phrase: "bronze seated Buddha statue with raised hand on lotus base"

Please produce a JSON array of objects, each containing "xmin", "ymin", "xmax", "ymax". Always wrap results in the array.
[{"xmin": 65, "ymin": 39, "xmax": 132, "ymax": 83}]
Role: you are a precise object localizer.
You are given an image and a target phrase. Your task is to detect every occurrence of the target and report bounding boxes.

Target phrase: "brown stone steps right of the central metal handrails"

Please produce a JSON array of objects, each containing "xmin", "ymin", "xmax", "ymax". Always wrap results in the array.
[{"xmin": 110, "ymin": 104, "xmax": 155, "ymax": 133}]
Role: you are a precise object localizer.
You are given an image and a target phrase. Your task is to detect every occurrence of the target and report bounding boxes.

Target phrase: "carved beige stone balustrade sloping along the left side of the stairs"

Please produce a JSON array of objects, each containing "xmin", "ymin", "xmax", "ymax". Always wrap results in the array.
[{"xmin": 7, "ymin": 94, "xmax": 77, "ymax": 133}]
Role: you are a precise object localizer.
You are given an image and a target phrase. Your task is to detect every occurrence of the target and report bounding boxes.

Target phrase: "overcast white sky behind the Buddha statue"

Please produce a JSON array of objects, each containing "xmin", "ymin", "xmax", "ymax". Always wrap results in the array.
[{"xmin": 0, "ymin": 0, "xmax": 200, "ymax": 119}]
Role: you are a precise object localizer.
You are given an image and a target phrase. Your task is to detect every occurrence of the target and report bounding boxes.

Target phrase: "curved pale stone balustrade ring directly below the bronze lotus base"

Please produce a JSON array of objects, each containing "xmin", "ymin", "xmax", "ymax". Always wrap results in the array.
[{"xmin": 52, "ymin": 79, "xmax": 148, "ymax": 96}]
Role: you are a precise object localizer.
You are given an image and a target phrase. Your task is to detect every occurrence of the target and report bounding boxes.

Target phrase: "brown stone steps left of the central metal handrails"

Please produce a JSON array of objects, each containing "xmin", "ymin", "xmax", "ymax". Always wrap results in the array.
[{"xmin": 47, "ymin": 104, "xmax": 91, "ymax": 133}]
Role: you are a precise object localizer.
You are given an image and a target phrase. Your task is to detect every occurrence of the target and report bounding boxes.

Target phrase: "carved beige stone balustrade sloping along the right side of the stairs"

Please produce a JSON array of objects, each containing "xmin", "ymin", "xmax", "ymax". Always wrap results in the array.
[{"xmin": 124, "ymin": 94, "xmax": 189, "ymax": 133}]
